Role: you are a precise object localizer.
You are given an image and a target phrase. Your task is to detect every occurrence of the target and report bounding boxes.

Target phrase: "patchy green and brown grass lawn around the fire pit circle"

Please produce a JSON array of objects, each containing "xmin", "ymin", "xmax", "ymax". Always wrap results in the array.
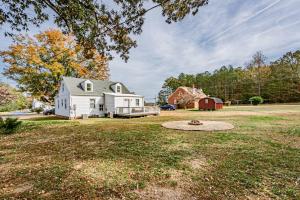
[{"xmin": 0, "ymin": 105, "xmax": 300, "ymax": 199}]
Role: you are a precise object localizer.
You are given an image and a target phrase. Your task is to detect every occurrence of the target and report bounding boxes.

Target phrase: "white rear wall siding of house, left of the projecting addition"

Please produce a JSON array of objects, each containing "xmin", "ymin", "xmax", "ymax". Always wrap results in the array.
[{"xmin": 70, "ymin": 96, "xmax": 105, "ymax": 118}]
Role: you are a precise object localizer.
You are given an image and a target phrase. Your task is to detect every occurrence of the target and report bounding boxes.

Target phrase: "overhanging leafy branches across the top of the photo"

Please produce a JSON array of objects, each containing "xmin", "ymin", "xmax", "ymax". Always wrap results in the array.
[{"xmin": 0, "ymin": 0, "xmax": 208, "ymax": 60}]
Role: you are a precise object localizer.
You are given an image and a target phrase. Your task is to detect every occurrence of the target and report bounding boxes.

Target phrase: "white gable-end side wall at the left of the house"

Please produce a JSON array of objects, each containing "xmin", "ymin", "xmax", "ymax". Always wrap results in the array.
[{"xmin": 55, "ymin": 81, "xmax": 70, "ymax": 117}]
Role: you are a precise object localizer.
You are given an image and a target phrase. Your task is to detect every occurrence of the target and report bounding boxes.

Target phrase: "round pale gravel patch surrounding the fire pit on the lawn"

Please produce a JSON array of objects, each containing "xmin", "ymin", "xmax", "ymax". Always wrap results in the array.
[{"xmin": 162, "ymin": 121, "xmax": 234, "ymax": 131}]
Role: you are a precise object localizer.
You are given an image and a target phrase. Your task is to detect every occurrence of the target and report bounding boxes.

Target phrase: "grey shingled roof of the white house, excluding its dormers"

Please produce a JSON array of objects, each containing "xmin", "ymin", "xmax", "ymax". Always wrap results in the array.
[{"xmin": 62, "ymin": 76, "xmax": 132, "ymax": 96}]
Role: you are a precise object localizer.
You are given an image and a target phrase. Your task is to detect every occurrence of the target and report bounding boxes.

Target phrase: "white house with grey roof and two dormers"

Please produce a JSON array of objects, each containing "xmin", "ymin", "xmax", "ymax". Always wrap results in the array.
[{"xmin": 55, "ymin": 77, "xmax": 149, "ymax": 118}]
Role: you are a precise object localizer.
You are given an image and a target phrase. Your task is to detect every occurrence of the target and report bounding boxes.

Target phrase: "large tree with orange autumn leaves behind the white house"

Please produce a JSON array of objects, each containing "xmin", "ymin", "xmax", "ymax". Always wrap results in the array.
[{"xmin": 0, "ymin": 30, "xmax": 108, "ymax": 103}]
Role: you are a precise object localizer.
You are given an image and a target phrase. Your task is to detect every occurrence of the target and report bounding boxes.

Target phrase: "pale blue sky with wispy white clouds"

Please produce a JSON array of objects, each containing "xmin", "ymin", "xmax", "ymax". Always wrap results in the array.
[{"xmin": 0, "ymin": 0, "xmax": 300, "ymax": 101}]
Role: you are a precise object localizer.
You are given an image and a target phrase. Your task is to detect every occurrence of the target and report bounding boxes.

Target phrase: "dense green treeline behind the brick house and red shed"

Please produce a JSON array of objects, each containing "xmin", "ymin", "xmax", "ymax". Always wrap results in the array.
[{"xmin": 159, "ymin": 50, "xmax": 300, "ymax": 103}]
